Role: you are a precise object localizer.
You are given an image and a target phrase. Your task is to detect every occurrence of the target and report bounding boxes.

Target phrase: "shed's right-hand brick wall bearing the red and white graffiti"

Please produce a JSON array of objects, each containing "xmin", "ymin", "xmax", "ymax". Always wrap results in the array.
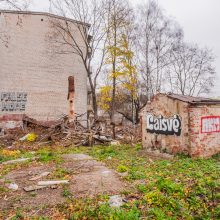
[{"xmin": 190, "ymin": 105, "xmax": 220, "ymax": 157}]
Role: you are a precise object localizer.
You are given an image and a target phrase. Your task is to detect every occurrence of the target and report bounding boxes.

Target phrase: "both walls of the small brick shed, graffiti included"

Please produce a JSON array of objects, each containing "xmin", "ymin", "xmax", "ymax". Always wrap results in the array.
[{"xmin": 142, "ymin": 94, "xmax": 220, "ymax": 157}]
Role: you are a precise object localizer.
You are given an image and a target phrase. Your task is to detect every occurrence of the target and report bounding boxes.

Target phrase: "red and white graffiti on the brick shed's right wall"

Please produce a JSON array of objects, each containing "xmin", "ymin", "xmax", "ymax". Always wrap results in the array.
[{"xmin": 201, "ymin": 116, "xmax": 220, "ymax": 133}]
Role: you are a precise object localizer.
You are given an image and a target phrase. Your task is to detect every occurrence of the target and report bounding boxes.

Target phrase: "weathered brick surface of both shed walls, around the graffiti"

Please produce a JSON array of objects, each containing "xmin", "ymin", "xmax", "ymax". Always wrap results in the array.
[{"xmin": 142, "ymin": 94, "xmax": 220, "ymax": 157}]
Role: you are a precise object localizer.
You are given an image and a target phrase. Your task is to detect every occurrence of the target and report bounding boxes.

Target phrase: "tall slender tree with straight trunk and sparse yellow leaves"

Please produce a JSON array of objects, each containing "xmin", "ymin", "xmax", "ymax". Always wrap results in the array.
[{"xmin": 101, "ymin": 0, "xmax": 131, "ymax": 138}]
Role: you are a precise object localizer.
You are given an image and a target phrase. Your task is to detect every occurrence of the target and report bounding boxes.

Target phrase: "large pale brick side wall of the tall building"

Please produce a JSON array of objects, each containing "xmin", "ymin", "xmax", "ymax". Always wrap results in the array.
[{"xmin": 0, "ymin": 12, "xmax": 87, "ymax": 126}]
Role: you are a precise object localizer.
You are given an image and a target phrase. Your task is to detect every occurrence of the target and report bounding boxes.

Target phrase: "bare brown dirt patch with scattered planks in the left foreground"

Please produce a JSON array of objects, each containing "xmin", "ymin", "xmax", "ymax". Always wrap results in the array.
[{"xmin": 0, "ymin": 154, "xmax": 124, "ymax": 211}]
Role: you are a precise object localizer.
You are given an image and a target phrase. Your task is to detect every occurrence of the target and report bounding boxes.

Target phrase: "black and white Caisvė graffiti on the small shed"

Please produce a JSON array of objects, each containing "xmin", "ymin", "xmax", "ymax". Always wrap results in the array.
[{"xmin": 146, "ymin": 114, "xmax": 182, "ymax": 136}]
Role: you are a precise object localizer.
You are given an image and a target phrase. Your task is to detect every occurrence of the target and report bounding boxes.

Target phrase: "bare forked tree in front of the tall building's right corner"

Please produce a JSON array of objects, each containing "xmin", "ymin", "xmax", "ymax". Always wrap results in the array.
[{"xmin": 52, "ymin": 0, "xmax": 106, "ymax": 119}]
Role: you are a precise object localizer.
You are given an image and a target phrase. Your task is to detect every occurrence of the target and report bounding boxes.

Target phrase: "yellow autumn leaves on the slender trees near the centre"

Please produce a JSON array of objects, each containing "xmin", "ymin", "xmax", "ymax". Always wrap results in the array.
[{"xmin": 103, "ymin": 34, "xmax": 137, "ymax": 108}]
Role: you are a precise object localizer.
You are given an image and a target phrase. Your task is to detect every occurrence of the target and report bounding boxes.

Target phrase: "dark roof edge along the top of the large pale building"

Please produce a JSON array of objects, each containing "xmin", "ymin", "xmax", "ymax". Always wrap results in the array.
[{"xmin": 0, "ymin": 9, "xmax": 90, "ymax": 28}]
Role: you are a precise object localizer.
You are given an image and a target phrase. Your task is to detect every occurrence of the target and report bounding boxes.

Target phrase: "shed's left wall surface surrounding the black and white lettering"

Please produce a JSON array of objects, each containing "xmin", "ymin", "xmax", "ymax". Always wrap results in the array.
[{"xmin": 142, "ymin": 94, "xmax": 189, "ymax": 154}]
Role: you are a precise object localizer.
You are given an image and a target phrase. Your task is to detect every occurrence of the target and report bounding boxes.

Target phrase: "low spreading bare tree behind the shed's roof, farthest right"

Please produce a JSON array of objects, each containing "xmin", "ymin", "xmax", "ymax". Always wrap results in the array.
[{"xmin": 167, "ymin": 42, "xmax": 215, "ymax": 96}]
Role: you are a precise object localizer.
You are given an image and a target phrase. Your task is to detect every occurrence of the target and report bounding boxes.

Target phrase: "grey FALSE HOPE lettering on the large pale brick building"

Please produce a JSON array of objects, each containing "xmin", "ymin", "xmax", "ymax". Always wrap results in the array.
[{"xmin": 0, "ymin": 92, "xmax": 27, "ymax": 112}]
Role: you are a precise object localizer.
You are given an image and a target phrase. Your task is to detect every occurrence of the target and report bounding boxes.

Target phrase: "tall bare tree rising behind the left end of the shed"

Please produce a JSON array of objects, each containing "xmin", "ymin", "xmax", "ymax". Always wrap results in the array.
[{"xmin": 137, "ymin": 1, "xmax": 183, "ymax": 97}]
